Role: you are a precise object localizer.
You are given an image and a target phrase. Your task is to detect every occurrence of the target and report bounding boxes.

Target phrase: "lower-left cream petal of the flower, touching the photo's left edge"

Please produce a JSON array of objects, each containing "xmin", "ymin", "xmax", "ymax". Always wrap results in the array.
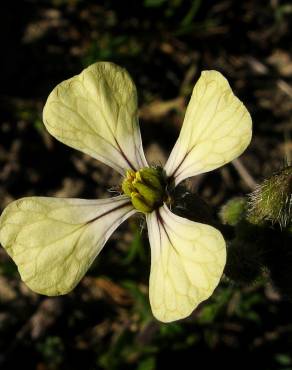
[{"xmin": 0, "ymin": 196, "xmax": 136, "ymax": 296}]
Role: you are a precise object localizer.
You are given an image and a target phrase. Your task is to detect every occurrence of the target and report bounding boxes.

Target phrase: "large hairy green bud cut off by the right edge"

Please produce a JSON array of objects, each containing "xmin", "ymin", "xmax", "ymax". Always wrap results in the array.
[{"xmin": 248, "ymin": 166, "xmax": 292, "ymax": 228}]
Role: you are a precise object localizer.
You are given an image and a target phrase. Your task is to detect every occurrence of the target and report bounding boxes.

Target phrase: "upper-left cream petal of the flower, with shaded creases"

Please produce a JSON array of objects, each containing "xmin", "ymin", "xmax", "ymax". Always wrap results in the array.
[{"xmin": 43, "ymin": 62, "xmax": 147, "ymax": 175}]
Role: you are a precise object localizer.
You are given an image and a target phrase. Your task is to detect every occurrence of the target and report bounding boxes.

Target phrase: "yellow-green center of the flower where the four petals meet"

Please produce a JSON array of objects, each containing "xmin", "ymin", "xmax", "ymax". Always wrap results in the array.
[{"xmin": 122, "ymin": 167, "xmax": 167, "ymax": 213}]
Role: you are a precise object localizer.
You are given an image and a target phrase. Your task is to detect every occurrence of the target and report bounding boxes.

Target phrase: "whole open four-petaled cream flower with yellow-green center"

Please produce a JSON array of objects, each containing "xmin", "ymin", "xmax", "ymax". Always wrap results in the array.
[{"xmin": 0, "ymin": 62, "xmax": 251, "ymax": 322}]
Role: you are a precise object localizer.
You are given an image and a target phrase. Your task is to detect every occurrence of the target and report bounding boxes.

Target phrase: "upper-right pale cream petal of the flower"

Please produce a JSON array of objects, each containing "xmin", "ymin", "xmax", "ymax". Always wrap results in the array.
[{"xmin": 164, "ymin": 71, "xmax": 252, "ymax": 185}]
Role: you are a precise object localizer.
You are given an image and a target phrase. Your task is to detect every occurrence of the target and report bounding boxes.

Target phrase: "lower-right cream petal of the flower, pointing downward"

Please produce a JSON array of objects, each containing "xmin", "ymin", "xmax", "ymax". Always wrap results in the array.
[{"xmin": 146, "ymin": 205, "xmax": 226, "ymax": 322}]
